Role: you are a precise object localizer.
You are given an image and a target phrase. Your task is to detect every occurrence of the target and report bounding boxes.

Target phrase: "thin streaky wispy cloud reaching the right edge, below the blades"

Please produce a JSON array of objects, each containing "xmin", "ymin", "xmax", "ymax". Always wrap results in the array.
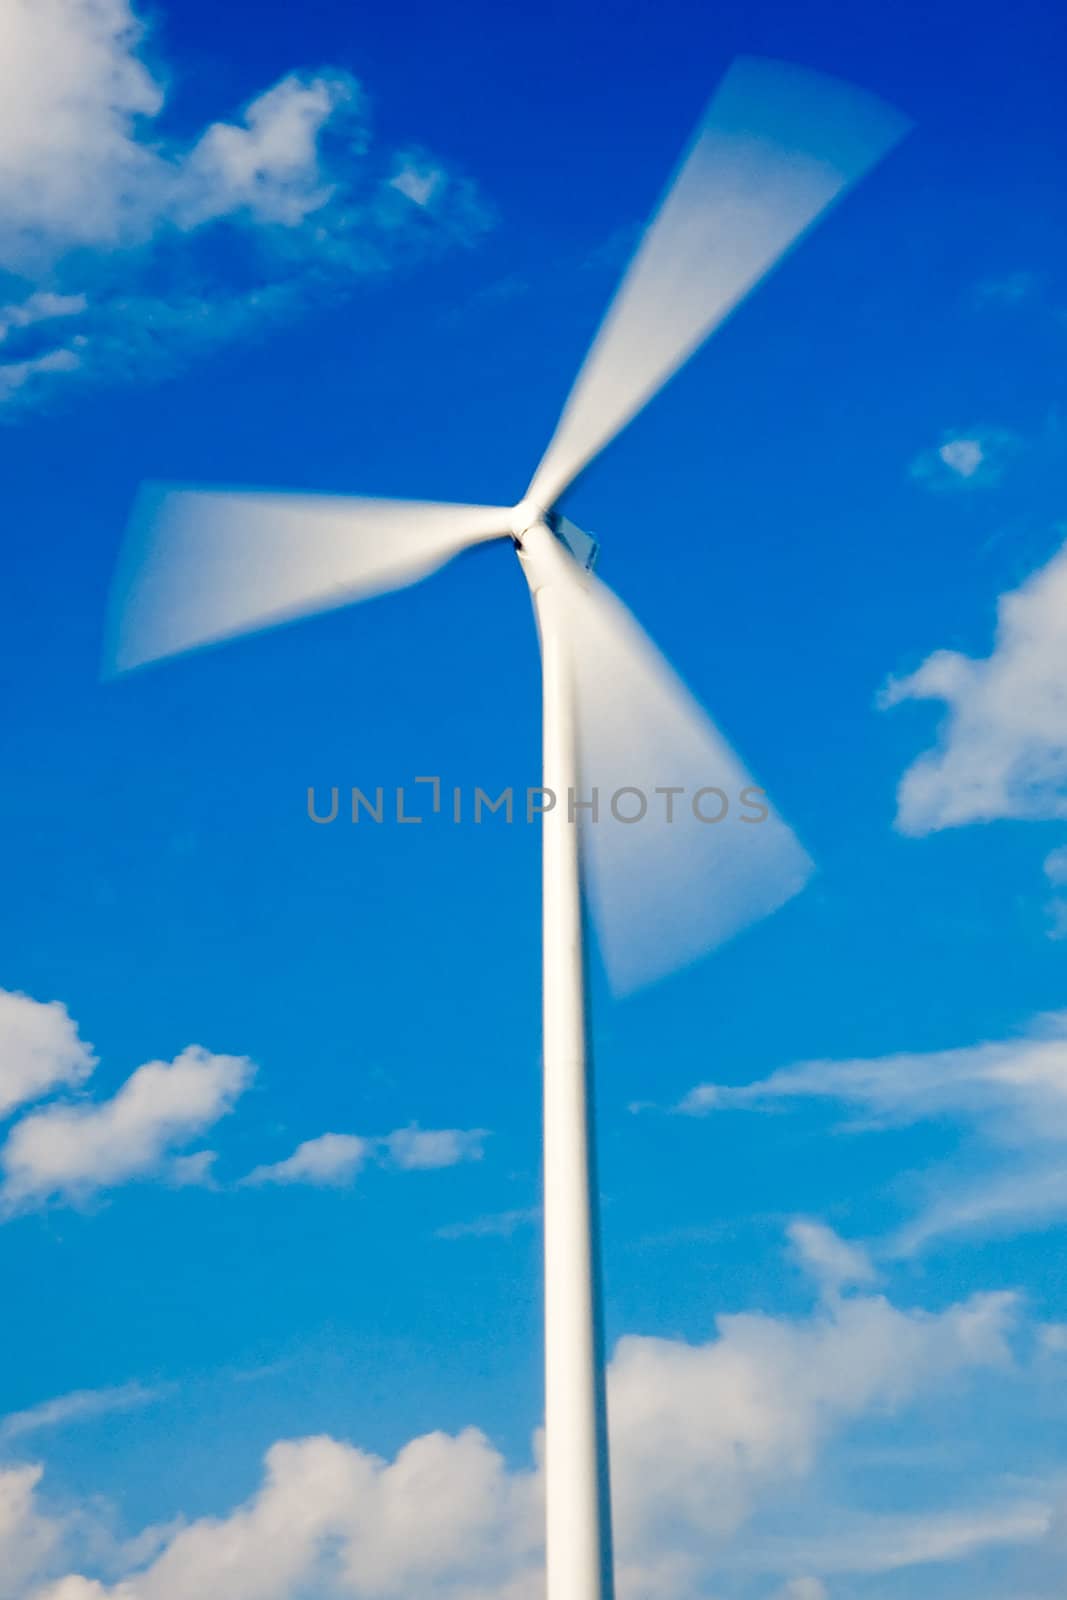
[{"xmin": 683, "ymin": 1011, "xmax": 1067, "ymax": 1254}]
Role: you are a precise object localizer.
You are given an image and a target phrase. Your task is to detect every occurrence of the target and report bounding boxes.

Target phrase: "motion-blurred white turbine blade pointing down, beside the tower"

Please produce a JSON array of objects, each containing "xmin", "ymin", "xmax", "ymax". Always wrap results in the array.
[{"xmin": 560, "ymin": 570, "xmax": 814, "ymax": 992}]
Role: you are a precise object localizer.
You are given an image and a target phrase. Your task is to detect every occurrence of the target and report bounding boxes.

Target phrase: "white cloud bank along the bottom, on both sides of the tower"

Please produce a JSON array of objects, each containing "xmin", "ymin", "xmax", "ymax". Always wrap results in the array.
[{"xmin": 4, "ymin": 1273, "xmax": 1029, "ymax": 1600}]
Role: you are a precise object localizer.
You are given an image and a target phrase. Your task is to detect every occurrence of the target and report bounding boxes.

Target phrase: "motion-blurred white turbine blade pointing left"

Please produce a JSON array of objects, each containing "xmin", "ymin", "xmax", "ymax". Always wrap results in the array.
[{"xmin": 106, "ymin": 485, "xmax": 510, "ymax": 672}]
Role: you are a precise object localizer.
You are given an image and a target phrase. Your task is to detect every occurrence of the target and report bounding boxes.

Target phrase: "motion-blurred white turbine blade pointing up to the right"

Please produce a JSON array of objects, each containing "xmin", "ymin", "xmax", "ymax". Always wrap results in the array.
[{"xmin": 526, "ymin": 58, "xmax": 910, "ymax": 509}]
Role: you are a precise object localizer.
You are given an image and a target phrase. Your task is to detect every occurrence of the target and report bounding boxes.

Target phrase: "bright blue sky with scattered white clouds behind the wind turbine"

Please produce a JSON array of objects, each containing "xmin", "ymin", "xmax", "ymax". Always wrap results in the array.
[{"xmin": 0, "ymin": 0, "xmax": 1067, "ymax": 1600}]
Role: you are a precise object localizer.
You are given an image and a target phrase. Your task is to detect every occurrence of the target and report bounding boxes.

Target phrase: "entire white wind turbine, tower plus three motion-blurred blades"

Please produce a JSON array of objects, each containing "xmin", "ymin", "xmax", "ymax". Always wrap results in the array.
[{"xmin": 107, "ymin": 59, "xmax": 909, "ymax": 1600}]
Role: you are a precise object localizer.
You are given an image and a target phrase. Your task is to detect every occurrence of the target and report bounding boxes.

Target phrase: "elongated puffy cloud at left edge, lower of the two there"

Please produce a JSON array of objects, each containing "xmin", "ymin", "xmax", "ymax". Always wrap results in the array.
[{"xmin": 0, "ymin": 1045, "xmax": 254, "ymax": 1210}]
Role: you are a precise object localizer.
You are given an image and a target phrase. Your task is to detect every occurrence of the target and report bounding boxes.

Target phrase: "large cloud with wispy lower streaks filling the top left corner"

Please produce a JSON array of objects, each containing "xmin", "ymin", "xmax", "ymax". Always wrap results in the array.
[{"xmin": 0, "ymin": 0, "xmax": 488, "ymax": 411}]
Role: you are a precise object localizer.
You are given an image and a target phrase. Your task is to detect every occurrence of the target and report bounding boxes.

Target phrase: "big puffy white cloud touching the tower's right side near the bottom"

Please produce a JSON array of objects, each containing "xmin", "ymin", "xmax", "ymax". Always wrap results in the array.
[{"xmin": 609, "ymin": 1294, "xmax": 1016, "ymax": 1571}]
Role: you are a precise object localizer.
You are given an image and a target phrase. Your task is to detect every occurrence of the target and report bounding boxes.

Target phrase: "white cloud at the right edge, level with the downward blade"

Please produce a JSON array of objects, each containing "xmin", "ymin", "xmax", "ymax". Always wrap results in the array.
[{"xmin": 881, "ymin": 546, "xmax": 1067, "ymax": 834}]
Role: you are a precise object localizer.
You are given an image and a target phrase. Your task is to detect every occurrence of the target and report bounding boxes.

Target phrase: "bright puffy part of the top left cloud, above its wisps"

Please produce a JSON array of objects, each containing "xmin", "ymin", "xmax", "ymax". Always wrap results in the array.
[{"xmin": 0, "ymin": 0, "xmax": 365, "ymax": 257}]
